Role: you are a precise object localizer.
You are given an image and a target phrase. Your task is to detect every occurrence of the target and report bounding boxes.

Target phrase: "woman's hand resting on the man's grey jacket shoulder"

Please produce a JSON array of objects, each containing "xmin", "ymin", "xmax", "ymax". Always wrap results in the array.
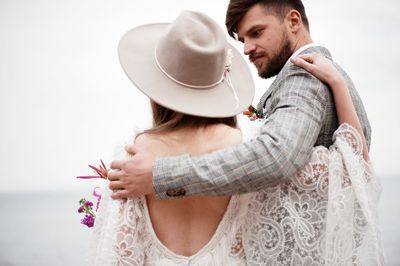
[{"xmin": 291, "ymin": 53, "xmax": 346, "ymax": 89}]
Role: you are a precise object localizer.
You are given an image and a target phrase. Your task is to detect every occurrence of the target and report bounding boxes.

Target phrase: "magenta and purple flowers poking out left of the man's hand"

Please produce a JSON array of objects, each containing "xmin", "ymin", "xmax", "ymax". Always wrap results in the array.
[{"xmin": 76, "ymin": 160, "xmax": 109, "ymax": 228}]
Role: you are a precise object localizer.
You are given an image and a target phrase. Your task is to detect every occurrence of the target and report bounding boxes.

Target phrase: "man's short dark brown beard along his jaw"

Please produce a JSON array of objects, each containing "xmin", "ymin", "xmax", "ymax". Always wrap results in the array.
[{"xmin": 258, "ymin": 32, "xmax": 293, "ymax": 79}]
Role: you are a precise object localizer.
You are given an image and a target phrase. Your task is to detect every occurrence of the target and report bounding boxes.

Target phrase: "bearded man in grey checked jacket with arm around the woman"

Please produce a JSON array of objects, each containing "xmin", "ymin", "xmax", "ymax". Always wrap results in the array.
[{"xmin": 109, "ymin": 0, "xmax": 371, "ymax": 199}]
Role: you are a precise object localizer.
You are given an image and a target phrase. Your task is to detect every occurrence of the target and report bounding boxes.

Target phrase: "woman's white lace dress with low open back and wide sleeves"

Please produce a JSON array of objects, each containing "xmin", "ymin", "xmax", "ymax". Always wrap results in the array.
[{"xmin": 91, "ymin": 124, "xmax": 384, "ymax": 266}]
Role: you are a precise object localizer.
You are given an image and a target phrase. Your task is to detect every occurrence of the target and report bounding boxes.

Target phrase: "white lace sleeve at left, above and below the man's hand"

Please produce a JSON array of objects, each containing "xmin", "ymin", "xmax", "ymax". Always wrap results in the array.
[{"xmin": 89, "ymin": 130, "xmax": 144, "ymax": 266}]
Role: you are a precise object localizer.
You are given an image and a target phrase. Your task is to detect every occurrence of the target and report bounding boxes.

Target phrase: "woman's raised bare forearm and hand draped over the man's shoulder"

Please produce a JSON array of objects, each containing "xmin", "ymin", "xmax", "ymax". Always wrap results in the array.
[{"xmin": 291, "ymin": 53, "xmax": 369, "ymax": 161}]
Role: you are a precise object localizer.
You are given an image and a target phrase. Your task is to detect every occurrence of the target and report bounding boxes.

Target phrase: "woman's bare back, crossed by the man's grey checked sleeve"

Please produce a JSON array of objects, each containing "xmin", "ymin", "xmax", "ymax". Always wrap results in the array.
[{"xmin": 136, "ymin": 125, "xmax": 242, "ymax": 256}]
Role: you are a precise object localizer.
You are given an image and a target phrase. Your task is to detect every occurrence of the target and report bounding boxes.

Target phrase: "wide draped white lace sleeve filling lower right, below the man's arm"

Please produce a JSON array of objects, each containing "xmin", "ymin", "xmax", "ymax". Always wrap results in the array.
[{"xmin": 241, "ymin": 121, "xmax": 384, "ymax": 266}]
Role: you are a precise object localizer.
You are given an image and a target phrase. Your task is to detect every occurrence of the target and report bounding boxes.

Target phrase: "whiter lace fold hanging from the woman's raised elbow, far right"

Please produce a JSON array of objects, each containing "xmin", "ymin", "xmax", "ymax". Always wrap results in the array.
[{"xmin": 324, "ymin": 124, "xmax": 384, "ymax": 265}]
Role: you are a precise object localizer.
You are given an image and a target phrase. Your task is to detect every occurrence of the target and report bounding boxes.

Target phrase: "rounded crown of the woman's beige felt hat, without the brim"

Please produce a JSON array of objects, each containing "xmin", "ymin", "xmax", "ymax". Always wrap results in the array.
[{"xmin": 155, "ymin": 11, "xmax": 227, "ymax": 87}]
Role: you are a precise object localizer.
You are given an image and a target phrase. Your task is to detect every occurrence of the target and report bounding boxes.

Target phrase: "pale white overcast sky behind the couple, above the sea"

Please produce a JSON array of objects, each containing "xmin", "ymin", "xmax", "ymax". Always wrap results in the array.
[{"xmin": 0, "ymin": 0, "xmax": 400, "ymax": 191}]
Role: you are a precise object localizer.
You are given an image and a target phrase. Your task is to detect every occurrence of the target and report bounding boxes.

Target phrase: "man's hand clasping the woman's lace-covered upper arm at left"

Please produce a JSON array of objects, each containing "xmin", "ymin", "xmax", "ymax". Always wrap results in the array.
[{"xmin": 108, "ymin": 145, "xmax": 155, "ymax": 199}]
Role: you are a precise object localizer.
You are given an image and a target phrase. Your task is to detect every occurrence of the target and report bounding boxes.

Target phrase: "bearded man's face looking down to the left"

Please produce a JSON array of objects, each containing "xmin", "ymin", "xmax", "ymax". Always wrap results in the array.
[{"xmin": 237, "ymin": 4, "xmax": 293, "ymax": 78}]
